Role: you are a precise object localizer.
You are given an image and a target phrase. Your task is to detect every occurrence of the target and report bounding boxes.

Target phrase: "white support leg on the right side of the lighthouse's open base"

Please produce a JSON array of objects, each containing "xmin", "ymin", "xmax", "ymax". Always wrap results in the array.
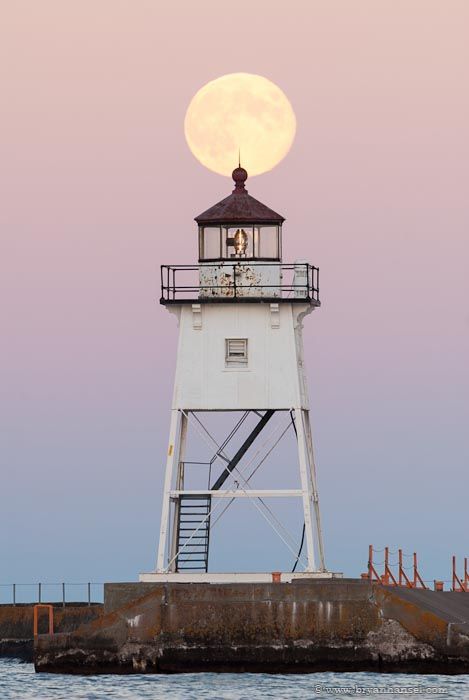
[{"xmin": 295, "ymin": 408, "xmax": 326, "ymax": 571}]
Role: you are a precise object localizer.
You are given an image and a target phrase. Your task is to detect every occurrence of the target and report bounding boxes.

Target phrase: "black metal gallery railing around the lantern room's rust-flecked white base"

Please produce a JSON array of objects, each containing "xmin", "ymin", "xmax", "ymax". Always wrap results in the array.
[{"xmin": 160, "ymin": 261, "xmax": 320, "ymax": 306}]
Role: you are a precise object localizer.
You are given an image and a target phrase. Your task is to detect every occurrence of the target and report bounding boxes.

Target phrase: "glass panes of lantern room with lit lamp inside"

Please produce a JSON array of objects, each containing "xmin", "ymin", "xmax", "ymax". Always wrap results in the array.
[{"xmin": 199, "ymin": 224, "xmax": 282, "ymax": 261}]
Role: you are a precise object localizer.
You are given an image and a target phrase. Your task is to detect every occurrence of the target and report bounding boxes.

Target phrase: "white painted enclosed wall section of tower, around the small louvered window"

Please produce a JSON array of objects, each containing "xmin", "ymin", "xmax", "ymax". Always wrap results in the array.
[{"xmin": 168, "ymin": 302, "xmax": 314, "ymax": 410}]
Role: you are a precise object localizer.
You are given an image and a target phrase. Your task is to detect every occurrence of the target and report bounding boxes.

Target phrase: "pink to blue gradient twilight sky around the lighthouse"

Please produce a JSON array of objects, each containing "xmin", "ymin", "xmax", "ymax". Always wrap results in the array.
[{"xmin": 0, "ymin": 0, "xmax": 469, "ymax": 583}]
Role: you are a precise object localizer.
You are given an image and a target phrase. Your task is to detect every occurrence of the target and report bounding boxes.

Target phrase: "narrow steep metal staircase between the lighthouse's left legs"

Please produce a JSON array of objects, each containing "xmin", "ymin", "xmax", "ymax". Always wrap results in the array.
[{"xmin": 176, "ymin": 495, "xmax": 212, "ymax": 572}]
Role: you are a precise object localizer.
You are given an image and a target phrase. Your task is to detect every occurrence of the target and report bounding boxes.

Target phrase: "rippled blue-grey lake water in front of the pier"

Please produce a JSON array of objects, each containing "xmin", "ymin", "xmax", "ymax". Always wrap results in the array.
[{"xmin": 0, "ymin": 659, "xmax": 469, "ymax": 700}]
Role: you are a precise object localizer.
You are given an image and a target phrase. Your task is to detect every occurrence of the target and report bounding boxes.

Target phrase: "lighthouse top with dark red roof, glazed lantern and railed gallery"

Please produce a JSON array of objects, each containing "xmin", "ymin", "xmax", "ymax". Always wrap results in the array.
[{"xmin": 161, "ymin": 166, "xmax": 319, "ymax": 306}]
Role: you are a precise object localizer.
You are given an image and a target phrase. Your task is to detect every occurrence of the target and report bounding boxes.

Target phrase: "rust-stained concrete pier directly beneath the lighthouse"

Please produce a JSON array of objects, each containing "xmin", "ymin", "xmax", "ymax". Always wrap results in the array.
[{"xmin": 34, "ymin": 579, "xmax": 469, "ymax": 673}]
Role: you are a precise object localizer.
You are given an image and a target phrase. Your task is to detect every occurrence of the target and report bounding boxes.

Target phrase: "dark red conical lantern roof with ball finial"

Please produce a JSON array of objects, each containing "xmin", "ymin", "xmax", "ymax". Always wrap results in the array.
[{"xmin": 195, "ymin": 167, "xmax": 285, "ymax": 225}]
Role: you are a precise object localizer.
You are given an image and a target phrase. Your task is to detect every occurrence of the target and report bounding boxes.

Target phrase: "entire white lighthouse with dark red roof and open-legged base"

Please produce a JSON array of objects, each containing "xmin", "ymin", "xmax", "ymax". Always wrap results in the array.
[{"xmin": 140, "ymin": 167, "xmax": 333, "ymax": 582}]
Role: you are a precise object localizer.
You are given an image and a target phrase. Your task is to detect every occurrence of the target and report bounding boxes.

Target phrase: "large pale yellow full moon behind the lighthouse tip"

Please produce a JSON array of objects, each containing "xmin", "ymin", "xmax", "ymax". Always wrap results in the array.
[{"xmin": 184, "ymin": 73, "xmax": 296, "ymax": 176}]
